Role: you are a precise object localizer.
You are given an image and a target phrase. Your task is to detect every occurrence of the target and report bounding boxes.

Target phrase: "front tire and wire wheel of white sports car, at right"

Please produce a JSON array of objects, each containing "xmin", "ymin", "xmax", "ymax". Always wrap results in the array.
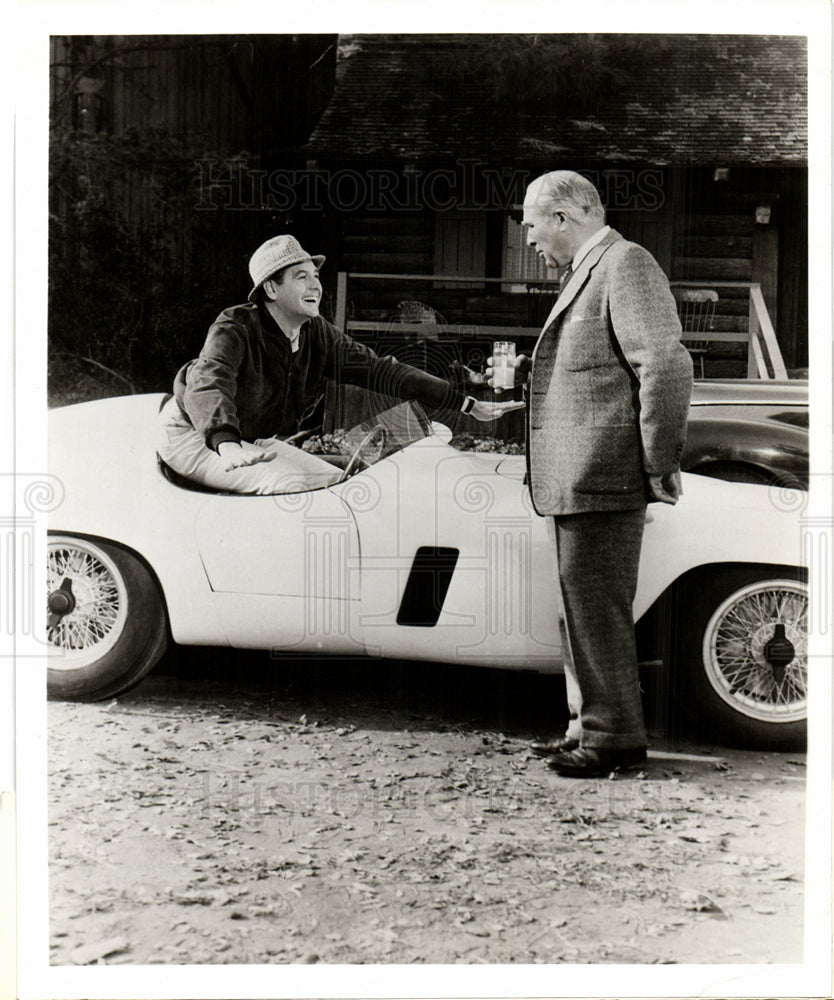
[{"xmin": 672, "ymin": 565, "xmax": 808, "ymax": 750}]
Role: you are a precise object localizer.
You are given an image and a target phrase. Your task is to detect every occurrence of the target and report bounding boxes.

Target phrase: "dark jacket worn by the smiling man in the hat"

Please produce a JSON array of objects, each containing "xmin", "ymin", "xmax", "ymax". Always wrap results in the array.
[{"xmin": 174, "ymin": 303, "xmax": 464, "ymax": 449}]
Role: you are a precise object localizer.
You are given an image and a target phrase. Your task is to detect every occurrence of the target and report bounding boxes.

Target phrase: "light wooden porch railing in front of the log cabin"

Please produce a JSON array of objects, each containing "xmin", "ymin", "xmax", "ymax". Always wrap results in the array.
[{"xmin": 335, "ymin": 271, "xmax": 788, "ymax": 379}]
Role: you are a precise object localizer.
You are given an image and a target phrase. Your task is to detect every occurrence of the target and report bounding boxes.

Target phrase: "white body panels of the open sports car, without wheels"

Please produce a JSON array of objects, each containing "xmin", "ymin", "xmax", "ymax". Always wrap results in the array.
[{"xmin": 49, "ymin": 395, "xmax": 801, "ymax": 671}]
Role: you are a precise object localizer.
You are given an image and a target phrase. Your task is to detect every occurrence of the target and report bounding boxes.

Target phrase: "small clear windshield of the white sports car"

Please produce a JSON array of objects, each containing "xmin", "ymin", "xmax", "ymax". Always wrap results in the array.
[{"xmin": 301, "ymin": 401, "xmax": 433, "ymax": 472}]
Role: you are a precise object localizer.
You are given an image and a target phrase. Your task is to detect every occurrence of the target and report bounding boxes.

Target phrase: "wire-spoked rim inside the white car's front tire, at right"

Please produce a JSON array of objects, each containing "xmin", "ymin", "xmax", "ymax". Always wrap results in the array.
[{"xmin": 703, "ymin": 580, "xmax": 808, "ymax": 723}]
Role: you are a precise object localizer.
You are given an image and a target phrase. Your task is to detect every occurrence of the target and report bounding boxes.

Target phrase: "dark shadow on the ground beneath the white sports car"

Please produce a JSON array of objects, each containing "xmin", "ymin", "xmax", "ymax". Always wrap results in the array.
[{"xmin": 120, "ymin": 647, "xmax": 692, "ymax": 742}]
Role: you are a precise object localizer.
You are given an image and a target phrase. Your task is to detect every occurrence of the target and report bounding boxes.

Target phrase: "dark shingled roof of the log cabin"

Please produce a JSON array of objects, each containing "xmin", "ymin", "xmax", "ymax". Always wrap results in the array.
[{"xmin": 304, "ymin": 34, "xmax": 808, "ymax": 167}]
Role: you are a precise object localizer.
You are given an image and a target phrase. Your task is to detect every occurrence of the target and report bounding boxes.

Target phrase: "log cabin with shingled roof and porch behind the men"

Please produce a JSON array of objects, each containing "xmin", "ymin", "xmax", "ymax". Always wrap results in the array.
[{"xmin": 304, "ymin": 35, "xmax": 808, "ymax": 398}]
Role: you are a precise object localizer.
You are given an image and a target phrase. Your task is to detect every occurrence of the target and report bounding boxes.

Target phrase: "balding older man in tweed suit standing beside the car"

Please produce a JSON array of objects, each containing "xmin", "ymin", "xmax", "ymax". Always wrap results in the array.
[{"xmin": 490, "ymin": 170, "xmax": 692, "ymax": 777}]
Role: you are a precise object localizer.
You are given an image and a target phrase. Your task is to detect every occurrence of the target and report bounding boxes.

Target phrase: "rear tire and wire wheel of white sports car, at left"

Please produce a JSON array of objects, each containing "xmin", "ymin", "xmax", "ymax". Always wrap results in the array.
[{"xmin": 47, "ymin": 535, "xmax": 168, "ymax": 701}]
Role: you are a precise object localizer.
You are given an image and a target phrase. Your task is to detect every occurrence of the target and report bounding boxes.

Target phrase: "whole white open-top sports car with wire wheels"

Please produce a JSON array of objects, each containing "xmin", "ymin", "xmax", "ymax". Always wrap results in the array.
[{"xmin": 48, "ymin": 395, "xmax": 808, "ymax": 748}]
